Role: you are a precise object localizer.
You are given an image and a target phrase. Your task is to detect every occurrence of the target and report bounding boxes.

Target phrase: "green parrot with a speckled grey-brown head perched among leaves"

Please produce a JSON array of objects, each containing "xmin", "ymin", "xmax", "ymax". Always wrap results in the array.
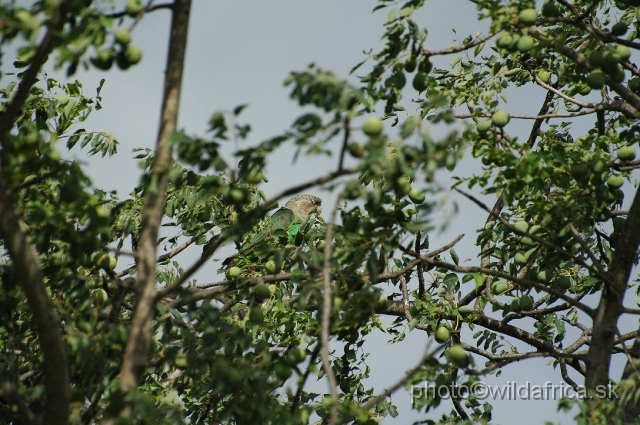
[{"xmin": 222, "ymin": 193, "xmax": 322, "ymax": 267}]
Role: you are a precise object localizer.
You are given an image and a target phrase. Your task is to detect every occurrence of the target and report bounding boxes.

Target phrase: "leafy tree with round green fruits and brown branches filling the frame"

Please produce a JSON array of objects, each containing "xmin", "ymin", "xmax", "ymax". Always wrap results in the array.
[{"xmin": 0, "ymin": 0, "xmax": 640, "ymax": 424}]
